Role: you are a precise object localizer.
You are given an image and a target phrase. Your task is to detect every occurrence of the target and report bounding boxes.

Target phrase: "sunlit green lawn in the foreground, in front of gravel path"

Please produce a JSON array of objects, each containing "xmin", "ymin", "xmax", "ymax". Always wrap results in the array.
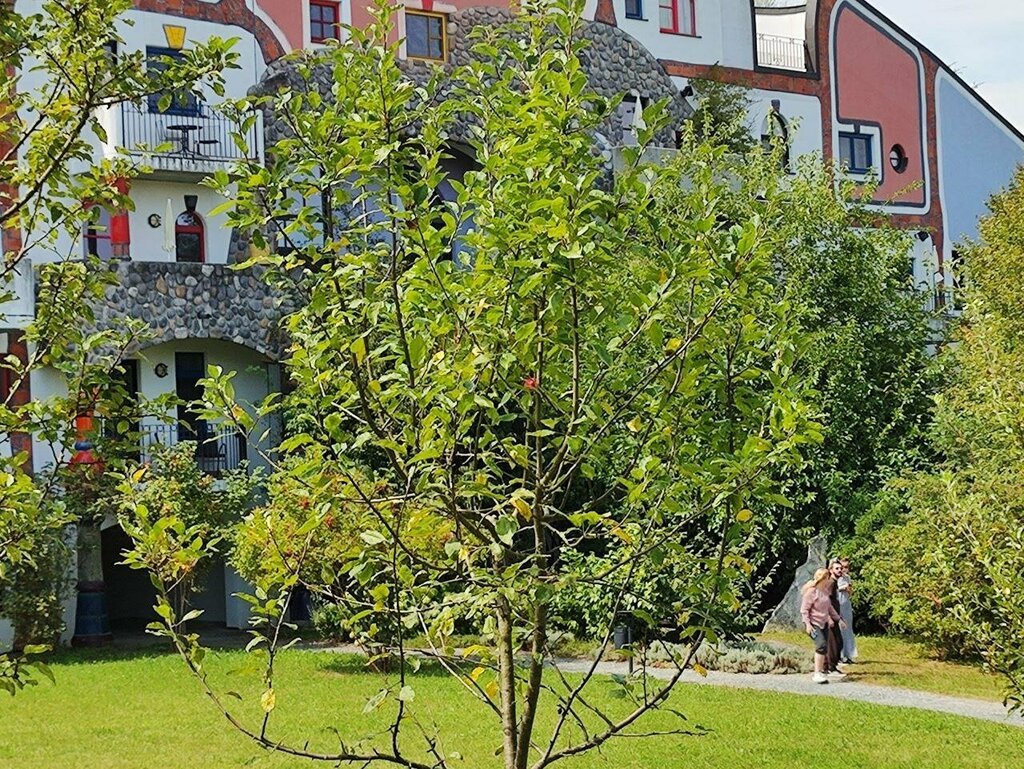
[{"xmin": 0, "ymin": 650, "xmax": 1024, "ymax": 769}]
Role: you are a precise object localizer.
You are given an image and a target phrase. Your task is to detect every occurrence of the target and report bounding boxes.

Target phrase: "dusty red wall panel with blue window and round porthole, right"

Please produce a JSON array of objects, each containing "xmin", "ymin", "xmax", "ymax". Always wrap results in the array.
[{"xmin": 834, "ymin": 5, "xmax": 928, "ymax": 207}]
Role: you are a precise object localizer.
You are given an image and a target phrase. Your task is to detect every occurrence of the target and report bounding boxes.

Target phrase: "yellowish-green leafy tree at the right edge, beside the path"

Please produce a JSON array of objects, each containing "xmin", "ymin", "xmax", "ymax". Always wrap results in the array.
[{"xmin": 867, "ymin": 172, "xmax": 1024, "ymax": 708}]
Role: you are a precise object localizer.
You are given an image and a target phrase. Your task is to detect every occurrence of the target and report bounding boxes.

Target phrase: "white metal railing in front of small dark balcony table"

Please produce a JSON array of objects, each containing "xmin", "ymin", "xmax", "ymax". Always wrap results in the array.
[{"xmin": 121, "ymin": 101, "xmax": 262, "ymax": 165}]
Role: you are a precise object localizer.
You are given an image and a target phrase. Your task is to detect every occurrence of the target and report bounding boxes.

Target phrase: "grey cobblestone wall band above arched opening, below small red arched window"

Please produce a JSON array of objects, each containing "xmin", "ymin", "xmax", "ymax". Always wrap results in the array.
[{"xmin": 84, "ymin": 262, "xmax": 288, "ymax": 360}]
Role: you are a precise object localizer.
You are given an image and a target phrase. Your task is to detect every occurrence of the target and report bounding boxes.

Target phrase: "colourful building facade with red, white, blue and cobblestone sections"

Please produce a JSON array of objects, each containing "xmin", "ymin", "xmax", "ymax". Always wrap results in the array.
[{"xmin": 0, "ymin": 0, "xmax": 1024, "ymax": 628}]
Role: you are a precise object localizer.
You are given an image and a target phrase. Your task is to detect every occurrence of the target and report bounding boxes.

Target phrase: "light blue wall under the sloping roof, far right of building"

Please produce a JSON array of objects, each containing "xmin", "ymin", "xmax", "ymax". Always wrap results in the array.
[{"xmin": 938, "ymin": 74, "xmax": 1024, "ymax": 246}]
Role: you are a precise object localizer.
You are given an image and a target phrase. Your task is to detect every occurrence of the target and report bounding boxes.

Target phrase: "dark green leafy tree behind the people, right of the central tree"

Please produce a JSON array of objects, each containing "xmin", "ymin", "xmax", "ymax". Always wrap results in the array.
[{"xmin": 761, "ymin": 159, "xmax": 941, "ymax": 562}]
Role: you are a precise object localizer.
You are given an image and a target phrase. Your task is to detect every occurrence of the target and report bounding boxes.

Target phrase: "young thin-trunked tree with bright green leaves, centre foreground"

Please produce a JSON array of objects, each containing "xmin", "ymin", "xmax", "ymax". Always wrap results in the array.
[{"xmin": 126, "ymin": 2, "xmax": 818, "ymax": 769}]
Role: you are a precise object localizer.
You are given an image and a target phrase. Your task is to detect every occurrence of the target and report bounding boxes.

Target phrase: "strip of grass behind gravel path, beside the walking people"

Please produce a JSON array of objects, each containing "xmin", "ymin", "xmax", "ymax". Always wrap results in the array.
[{"xmin": 758, "ymin": 633, "xmax": 1002, "ymax": 702}]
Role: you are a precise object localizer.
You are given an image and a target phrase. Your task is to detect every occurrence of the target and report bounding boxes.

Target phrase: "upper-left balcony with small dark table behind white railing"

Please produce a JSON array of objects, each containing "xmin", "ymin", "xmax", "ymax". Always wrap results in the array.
[{"xmin": 104, "ymin": 101, "xmax": 263, "ymax": 177}]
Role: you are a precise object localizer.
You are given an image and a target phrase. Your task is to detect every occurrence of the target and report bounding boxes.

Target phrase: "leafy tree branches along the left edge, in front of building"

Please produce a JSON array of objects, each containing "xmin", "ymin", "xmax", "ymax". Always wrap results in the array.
[{"xmin": 0, "ymin": 0, "xmax": 233, "ymax": 691}]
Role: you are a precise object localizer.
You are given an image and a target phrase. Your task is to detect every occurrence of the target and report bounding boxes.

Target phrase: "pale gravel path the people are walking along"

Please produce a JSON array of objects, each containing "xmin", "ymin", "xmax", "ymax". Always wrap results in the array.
[{"xmin": 558, "ymin": 659, "xmax": 1024, "ymax": 727}]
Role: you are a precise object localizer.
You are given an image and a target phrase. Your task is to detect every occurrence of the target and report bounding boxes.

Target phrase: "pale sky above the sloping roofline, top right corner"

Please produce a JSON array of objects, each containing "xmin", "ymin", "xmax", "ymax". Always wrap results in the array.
[{"xmin": 868, "ymin": 0, "xmax": 1024, "ymax": 131}]
